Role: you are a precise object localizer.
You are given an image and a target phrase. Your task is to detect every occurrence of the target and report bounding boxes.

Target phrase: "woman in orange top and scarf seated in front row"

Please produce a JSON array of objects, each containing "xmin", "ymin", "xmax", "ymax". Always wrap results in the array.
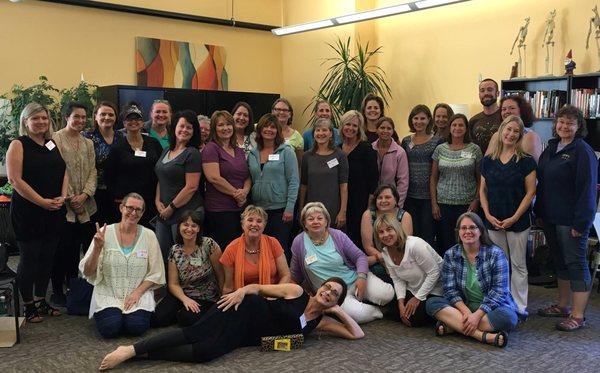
[{"xmin": 220, "ymin": 205, "xmax": 291, "ymax": 294}]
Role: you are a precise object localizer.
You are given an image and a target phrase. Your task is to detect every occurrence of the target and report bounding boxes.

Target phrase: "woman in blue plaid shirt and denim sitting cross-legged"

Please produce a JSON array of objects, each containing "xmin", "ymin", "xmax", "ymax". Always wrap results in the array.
[{"xmin": 426, "ymin": 212, "xmax": 519, "ymax": 347}]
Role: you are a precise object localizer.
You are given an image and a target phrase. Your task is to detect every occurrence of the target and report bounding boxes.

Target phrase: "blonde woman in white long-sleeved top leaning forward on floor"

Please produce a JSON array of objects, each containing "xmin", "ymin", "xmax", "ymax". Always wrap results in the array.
[{"xmin": 374, "ymin": 214, "xmax": 442, "ymax": 326}]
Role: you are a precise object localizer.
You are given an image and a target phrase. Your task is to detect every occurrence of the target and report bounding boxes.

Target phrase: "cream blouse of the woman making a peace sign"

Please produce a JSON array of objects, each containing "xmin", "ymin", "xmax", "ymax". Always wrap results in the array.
[{"xmin": 79, "ymin": 224, "xmax": 165, "ymax": 319}]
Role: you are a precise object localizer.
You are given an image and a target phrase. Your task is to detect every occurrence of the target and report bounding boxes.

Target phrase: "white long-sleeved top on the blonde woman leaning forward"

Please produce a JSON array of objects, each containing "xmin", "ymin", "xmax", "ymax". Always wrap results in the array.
[{"xmin": 382, "ymin": 236, "xmax": 443, "ymax": 301}]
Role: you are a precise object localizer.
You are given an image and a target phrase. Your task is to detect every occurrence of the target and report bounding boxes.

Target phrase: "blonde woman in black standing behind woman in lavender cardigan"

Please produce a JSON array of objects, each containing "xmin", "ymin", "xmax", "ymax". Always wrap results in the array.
[{"xmin": 340, "ymin": 110, "xmax": 379, "ymax": 248}]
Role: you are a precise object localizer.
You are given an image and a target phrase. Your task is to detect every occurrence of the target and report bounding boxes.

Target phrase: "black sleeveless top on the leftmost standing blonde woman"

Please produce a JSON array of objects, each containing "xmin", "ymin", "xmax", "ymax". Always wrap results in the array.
[{"xmin": 10, "ymin": 136, "xmax": 66, "ymax": 241}]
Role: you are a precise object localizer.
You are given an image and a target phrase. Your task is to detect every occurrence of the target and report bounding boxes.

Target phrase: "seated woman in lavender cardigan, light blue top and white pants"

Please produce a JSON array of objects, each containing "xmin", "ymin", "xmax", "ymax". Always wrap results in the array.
[{"xmin": 291, "ymin": 202, "xmax": 394, "ymax": 324}]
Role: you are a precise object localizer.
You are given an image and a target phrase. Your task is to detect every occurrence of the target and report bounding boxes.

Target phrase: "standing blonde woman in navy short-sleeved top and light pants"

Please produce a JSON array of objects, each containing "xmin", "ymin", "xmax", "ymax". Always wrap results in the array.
[{"xmin": 479, "ymin": 115, "xmax": 536, "ymax": 313}]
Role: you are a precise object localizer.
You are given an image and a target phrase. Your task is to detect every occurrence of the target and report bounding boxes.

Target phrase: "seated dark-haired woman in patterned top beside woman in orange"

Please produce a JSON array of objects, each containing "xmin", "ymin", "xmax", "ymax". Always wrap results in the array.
[{"xmin": 152, "ymin": 210, "xmax": 223, "ymax": 326}]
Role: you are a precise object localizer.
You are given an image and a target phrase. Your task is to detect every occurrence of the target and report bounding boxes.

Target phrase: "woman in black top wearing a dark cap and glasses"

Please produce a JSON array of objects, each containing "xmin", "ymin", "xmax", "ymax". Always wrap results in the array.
[{"xmin": 104, "ymin": 103, "xmax": 163, "ymax": 228}]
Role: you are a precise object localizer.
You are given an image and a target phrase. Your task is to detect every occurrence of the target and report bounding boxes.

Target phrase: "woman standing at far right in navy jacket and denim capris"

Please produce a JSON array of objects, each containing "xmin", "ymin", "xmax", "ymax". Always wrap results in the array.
[{"xmin": 535, "ymin": 105, "xmax": 598, "ymax": 332}]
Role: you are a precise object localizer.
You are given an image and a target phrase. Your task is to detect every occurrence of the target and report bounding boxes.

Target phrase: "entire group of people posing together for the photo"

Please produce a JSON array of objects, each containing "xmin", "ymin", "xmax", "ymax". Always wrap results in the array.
[{"xmin": 7, "ymin": 79, "xmax": 598, "ymax": 369}]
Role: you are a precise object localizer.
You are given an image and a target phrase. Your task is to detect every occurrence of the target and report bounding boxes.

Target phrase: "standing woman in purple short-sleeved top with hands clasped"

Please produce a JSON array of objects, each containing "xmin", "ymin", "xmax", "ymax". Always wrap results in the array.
[{"xmin": 202, "ymin": 110, "xmax": 251, "ymax": 247}]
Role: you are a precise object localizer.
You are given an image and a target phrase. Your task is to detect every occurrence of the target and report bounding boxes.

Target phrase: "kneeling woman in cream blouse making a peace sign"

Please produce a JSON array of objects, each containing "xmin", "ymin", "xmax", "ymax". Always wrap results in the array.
[{"xmin": 79, "ymin": 193, "xmax": 165, "ymax": 338}]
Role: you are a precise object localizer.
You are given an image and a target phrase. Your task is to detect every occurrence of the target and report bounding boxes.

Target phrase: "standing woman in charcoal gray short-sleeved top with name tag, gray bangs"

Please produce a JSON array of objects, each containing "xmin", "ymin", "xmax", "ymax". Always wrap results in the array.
[{"xmin": 300, "ymin": 118, "xmax": 348, "ymax": 229}]
